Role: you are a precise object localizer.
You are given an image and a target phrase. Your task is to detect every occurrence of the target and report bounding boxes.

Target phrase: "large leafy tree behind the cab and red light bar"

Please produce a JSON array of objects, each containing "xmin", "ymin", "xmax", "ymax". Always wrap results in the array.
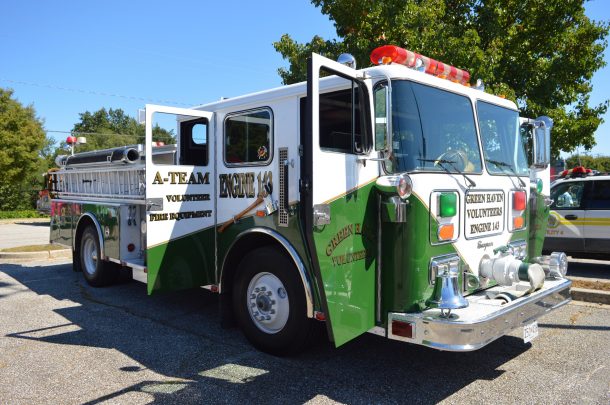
[{"xmin": 274, "ymin": 0, "xmax": 609, "ymax": 156}]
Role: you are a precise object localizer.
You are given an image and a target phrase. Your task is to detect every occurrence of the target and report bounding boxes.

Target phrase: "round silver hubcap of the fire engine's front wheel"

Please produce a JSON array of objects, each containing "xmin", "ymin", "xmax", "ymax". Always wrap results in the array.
[{"xmin": 246, "ymin": 272, "xmax": 290, "ymax": 334}]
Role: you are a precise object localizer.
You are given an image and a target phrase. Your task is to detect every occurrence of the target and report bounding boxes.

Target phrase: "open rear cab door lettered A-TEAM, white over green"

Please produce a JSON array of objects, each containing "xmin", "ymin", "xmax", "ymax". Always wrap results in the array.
[{"xmin": 145, "ymin": 105, "xmax": 215, "ymax": 294}]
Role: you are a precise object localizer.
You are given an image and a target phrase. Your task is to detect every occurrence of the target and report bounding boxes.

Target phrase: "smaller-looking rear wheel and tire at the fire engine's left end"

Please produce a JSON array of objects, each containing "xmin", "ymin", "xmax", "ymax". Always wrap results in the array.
[{"xmin": 78, "ymin": 226, "xmax": 118, "ymax": 287}]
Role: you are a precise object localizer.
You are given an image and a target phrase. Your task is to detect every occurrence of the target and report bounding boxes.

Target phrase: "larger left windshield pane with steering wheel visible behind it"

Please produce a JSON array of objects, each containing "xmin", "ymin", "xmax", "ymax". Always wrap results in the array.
[{"xmin": 386, "ymin": 80, "xmax": 481, "ymax": 173}]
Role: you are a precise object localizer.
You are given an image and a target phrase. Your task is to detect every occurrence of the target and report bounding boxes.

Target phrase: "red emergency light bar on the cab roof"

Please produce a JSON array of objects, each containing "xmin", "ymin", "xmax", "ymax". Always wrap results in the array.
[{"xmin": 371, "ymin": 45, "xmax": 470, "ymax": 86}]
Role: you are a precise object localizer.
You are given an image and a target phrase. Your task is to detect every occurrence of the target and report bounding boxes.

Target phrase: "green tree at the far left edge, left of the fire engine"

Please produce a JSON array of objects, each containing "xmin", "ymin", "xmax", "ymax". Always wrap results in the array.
[{"xmin": 0, "ymin": 88, "xmax": 51, "ymax": 210}]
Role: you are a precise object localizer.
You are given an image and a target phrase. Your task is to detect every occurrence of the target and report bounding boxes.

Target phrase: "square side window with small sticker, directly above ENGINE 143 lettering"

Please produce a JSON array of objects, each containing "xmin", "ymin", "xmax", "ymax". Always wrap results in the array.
[{"xmin": 224, "ymin": 108, "xmax": 273, "ymax": 166}]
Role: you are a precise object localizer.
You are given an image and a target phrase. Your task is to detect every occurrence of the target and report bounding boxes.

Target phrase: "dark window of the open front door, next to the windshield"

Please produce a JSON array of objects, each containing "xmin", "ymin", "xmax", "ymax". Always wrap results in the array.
[{"xmin": 320, "ymin": 85, "xmax": 367, "ymax": 153}]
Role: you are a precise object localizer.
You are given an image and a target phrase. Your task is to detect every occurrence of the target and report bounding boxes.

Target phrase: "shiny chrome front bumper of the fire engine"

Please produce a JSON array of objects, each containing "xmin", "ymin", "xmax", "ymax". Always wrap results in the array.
[{"xmin": 387, "ymin": 279, "xmax": 572, "ymax": 352}]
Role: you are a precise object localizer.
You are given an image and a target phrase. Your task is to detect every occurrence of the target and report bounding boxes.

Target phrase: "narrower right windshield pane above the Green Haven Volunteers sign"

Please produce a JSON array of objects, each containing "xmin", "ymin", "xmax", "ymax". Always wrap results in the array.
[{"xmin": 477, "ymin": 100, "xmax": 529, "ymax": 176}]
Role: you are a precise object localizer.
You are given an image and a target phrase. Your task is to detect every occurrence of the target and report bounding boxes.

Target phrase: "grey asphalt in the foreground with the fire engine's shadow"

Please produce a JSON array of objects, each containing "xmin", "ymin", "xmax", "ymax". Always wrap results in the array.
[{"xmin": 0, "ymin": 261, "xmax": 610, "ymax": 404}]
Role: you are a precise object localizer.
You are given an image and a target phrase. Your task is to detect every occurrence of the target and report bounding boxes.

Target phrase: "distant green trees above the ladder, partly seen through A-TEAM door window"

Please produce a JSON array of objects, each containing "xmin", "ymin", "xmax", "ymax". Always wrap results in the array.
[{"xmin": 56, "ymin": 108, "xmax": 176, "ymax": 154}]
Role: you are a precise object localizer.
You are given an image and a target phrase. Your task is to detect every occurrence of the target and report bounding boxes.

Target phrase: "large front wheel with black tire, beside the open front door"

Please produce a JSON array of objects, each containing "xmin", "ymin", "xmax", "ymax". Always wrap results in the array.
[{"xmin": 233, "ymin": 247, "xmax": 316, "ymax": 356}]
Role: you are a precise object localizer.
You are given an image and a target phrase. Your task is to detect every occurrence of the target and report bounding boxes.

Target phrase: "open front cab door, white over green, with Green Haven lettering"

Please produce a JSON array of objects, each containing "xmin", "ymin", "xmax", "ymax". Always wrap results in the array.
[{"xmin": 301, "ymin": 54, "xmax": 379, "ymax": 346}]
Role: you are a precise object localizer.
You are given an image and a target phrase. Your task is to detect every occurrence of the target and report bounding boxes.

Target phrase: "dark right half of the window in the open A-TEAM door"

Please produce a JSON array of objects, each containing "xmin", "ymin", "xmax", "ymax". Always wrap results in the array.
[{"xmin": 180, "ymin": 118, "xmax": 208, "ymax": 166}]
